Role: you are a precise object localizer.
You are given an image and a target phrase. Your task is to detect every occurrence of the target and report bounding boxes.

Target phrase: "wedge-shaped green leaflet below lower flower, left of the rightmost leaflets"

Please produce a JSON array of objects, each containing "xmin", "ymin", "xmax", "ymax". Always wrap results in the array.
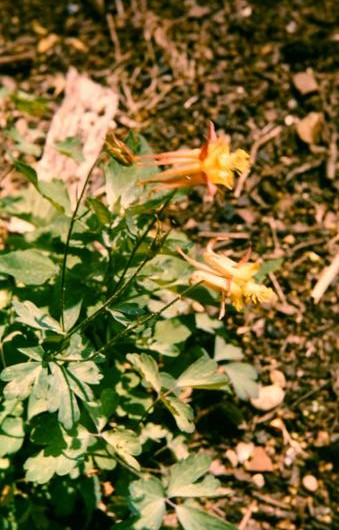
[{"xmin": 176, "ymin": 357, "xmax": 228, "ymax": 389}]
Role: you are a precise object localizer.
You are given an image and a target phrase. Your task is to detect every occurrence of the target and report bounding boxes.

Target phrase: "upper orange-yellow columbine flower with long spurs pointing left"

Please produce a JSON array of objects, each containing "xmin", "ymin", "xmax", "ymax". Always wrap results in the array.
[{"xmin": 136, "ymin": 122, "xmax": 249, "ymax": 197}]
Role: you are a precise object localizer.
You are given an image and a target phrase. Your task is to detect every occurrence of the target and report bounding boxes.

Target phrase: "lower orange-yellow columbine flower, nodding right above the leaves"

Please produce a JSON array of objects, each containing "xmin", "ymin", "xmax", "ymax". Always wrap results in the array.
[{"xmin": 177, "ymin": 245, "xmax": 276, "ymax": 319}]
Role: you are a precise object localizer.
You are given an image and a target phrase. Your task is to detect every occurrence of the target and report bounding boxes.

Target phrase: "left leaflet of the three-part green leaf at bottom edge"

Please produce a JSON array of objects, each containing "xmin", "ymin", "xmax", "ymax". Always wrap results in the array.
[{"xmin": 129, "ymin": 477, "xmax": 166, "ymax": 530}]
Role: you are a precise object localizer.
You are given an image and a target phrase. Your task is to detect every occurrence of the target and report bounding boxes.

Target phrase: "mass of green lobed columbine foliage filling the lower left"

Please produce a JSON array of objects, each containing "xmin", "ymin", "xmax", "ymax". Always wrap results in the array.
[{"xmin": 0, "ymin": 131, "xmax": 256, "ymax": 530}]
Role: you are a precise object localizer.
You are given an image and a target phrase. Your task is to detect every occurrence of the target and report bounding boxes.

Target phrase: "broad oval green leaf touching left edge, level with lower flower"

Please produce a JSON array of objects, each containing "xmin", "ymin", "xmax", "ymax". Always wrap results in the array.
[{"xmin": 0, "ymin": 249, "xmax": 58, "ymax": 285}]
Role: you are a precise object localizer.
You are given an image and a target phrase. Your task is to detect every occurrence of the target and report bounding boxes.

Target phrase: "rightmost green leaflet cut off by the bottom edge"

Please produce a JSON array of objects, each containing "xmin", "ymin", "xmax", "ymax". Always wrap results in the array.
[{"xmin": 175, "ymin": 504, "xmax": 236, "ymax": 530}]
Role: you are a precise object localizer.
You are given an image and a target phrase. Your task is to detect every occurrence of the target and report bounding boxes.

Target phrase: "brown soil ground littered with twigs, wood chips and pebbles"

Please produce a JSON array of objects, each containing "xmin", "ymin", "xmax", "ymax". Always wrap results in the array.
[{"xmin": 0, "ymin": 0, "xmax": 339, "ymax": 530}]
